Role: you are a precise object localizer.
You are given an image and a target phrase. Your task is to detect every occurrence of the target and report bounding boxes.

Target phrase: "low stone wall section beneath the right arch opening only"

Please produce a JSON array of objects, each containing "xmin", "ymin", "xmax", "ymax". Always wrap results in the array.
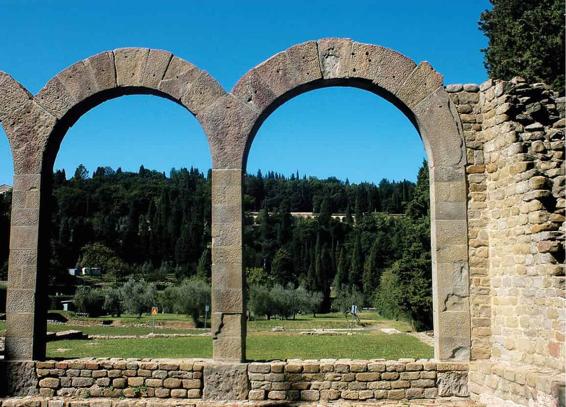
[{"xmin": 248, "ymin": 359, "xmax": 468, "ymax": 401}]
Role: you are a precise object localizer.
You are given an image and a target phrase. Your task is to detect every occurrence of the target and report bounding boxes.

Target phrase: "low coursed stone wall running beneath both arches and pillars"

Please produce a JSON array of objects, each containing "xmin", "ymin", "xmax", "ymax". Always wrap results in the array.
[{"xmin": 1, "ymin": 359, "xmax": 468, "ymax": 403}]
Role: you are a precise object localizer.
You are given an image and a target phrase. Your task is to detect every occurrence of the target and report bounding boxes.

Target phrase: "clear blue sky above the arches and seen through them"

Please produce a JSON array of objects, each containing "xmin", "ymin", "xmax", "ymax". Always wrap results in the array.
[{"xmin": 0, "ymin": 0, "xmax": 489, "ymax": 184}]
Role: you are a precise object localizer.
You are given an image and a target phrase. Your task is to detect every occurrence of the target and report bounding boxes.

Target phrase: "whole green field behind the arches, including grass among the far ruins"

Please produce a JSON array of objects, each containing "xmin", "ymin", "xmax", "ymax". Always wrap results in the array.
[{"xmin": 0, "ymin": 312, "xmax": 433, "ymax": 360}]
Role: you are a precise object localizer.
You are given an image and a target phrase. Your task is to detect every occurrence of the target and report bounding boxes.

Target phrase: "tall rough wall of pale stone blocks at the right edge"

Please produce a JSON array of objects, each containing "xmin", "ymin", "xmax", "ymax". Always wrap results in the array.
[{"xmin": 447, "ymin": 78, "xmax": 566, "ymax": 406}]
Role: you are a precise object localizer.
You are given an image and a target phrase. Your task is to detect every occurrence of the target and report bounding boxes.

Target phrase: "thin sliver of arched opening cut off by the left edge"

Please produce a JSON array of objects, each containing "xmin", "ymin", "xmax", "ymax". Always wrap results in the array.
[{"xmin": 0, "ymin": 128, "xmax": 14, "ymax": 357}]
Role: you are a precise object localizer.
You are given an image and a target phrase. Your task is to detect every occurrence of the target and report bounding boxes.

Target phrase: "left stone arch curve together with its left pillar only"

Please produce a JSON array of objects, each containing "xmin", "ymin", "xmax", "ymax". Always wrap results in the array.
[{"xmin": 0, "ymin": 48, "xmax": 226, "ymax": 360}]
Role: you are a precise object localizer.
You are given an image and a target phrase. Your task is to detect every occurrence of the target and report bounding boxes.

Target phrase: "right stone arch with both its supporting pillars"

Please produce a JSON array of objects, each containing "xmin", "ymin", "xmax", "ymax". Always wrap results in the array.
[{"xmin": 204, "ymin": 38, "xmax": 471, "ymax": 360}]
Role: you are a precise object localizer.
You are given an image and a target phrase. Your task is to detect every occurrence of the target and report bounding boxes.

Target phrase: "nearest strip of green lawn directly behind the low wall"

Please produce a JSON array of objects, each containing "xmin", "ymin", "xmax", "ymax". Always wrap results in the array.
[{"xmin": 47, "ymin": 333, "xmax": 433, "ymax": 360}]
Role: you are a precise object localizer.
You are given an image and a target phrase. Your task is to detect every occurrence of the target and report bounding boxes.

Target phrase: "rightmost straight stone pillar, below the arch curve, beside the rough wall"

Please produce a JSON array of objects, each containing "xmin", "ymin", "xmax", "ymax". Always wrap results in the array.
[{"xmin": 430, "ymin": 167, "xmax": 470, "ymax": 360}]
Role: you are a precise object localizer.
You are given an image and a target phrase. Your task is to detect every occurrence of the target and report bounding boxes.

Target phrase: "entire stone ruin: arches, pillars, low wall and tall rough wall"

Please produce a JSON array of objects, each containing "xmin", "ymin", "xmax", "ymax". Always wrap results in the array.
[{"xmin": 0, "ymin": 38, "xmax": 566, "ymax": 406}]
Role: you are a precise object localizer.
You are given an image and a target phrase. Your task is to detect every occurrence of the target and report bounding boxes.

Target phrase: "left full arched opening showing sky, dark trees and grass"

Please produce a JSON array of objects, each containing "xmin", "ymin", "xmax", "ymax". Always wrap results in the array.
[{"xmin": 42, "ymin": 95, "xmax": 211, "ymax": 358}]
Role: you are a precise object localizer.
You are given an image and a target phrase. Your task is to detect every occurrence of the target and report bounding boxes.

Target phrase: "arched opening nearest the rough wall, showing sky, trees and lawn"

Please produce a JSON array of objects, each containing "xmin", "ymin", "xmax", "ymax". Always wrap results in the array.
[{"xmin": 244, "ymin": 87, "xmax": 433, "ymax": 359}]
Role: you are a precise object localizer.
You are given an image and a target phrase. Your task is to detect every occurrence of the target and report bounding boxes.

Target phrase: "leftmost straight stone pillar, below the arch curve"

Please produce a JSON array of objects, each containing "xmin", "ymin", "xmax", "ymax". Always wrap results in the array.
[{"xmin": 5, "ymin": 174, "xmax": 47, "ymax": 361}]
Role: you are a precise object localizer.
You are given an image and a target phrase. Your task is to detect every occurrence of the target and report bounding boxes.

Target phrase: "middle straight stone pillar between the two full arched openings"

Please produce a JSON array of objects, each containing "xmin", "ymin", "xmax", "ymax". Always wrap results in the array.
[{"xmin": 211, "ymin": 169, "xmax": 246, "ymax": 362}]
